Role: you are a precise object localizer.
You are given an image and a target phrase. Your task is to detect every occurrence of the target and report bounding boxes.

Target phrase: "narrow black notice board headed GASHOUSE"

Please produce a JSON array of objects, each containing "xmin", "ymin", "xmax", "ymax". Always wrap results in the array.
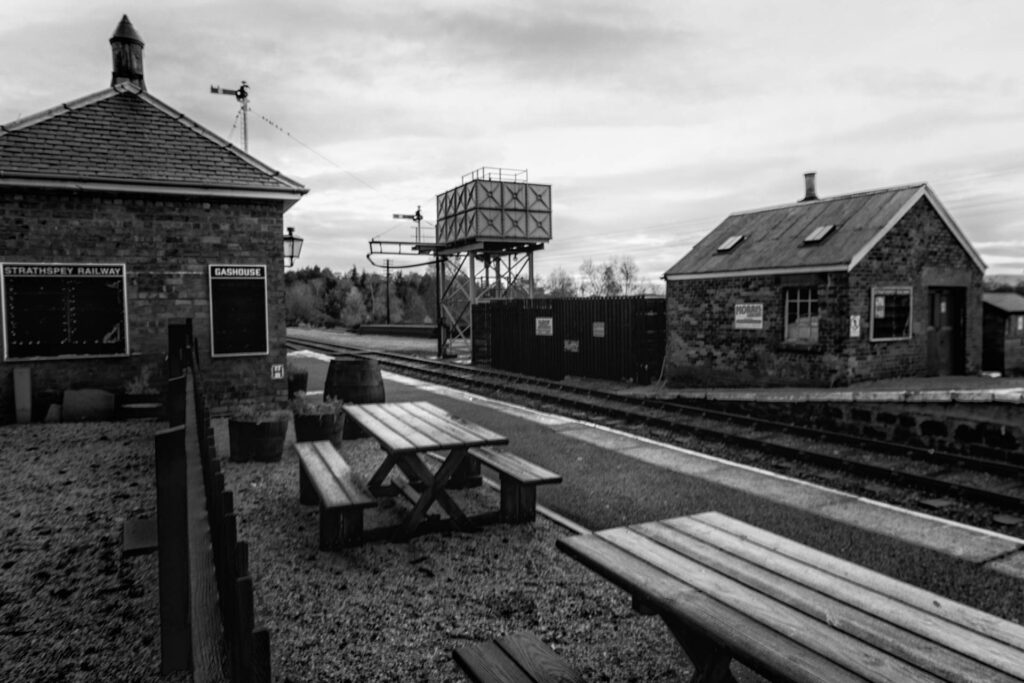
[{"xmin": 208, "ymin": 263, "xmax": 270, "ymax": 358}]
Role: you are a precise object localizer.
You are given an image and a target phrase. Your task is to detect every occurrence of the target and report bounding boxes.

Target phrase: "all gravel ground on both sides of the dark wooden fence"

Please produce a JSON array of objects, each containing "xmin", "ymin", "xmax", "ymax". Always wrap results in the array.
[{"xmin": 0, "ymin": 420, "xmax": 716, "ymax": 683}]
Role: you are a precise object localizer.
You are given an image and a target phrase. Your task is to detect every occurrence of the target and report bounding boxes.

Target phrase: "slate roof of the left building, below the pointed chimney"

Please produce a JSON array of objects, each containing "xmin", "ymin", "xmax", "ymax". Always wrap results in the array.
[{"xmin": 0, "ymin": 83, "xmax": 308, "ymax": 208}]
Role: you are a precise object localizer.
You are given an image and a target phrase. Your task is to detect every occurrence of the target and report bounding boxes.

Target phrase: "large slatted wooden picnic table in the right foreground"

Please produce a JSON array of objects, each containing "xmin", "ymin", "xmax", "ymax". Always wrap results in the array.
[{"xmin": 557, "ymin": 512, "xmax": 1024, "ymax": 683}]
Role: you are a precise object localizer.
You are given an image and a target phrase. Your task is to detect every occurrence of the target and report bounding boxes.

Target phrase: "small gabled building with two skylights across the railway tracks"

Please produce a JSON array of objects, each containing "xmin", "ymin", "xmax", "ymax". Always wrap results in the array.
[{"xmin": 665, "ymin": 173, "xmax": 985, "ymax": 386}]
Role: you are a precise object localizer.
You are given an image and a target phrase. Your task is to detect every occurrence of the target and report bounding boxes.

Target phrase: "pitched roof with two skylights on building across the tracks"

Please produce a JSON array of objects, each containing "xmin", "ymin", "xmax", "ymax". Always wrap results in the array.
[{"xmin": 665, "ymin": 183, "xmax": 985, "ymax": 280}]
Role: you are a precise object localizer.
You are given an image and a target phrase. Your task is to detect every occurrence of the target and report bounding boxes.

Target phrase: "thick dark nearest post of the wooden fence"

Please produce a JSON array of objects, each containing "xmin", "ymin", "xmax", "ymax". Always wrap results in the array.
[{"xmin": 157, "ymin": 423, "xmax": 191, "ymax": 676}]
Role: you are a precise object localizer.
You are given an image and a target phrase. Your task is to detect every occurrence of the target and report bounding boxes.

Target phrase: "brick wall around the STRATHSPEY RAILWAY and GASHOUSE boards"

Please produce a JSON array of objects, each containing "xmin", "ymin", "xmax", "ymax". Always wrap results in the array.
[{"xmin": 0, "ymin": 189, "xmax": 287, "ymax": 422}]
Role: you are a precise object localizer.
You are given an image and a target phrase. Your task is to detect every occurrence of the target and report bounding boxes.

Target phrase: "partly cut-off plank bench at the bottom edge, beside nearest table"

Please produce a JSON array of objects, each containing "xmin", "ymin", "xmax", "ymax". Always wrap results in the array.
[{"xmin": 453, "ymin": 632, "xmax": 583, "ymax": 683}]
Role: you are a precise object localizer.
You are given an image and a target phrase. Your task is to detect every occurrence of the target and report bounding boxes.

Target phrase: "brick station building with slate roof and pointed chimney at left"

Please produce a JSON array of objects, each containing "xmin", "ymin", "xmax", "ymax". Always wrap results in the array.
[{"xmin": 0, "ymin": 16, "xmax": 307, "ymax": 422}]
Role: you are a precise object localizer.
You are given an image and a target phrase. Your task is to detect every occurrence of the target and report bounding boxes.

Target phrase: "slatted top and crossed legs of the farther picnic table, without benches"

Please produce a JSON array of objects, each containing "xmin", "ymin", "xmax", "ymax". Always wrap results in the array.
[{"xmin": 343, "ymin": 401, "xmax": 509, "ymax": 537}]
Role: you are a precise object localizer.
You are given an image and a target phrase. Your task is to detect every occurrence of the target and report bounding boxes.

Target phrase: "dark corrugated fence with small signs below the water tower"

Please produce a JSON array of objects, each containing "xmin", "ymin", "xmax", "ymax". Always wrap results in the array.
[{"xmin": 473, "ymin": 297, "xmax": 665, "ymax": 384}]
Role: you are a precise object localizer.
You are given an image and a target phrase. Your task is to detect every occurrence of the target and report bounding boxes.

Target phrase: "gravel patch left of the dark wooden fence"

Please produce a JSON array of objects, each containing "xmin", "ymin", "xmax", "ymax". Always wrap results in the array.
[{"xmin": 0, "ymin": 420, "xmax": 188, "ymax": 682}]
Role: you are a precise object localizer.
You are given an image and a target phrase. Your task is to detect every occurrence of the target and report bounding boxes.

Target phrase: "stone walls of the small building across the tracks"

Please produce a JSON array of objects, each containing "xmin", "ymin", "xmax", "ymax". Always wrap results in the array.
[{"xmin": 666, "ymin": 200, "xmax": 982, "ymax": 386}]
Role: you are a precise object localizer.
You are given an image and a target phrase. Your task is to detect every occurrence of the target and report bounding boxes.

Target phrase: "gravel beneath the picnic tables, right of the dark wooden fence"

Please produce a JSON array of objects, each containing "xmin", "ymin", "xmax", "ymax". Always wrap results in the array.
[{"xmin": 225, "ymin": 428, "xmax": 704, "ymax": 682}]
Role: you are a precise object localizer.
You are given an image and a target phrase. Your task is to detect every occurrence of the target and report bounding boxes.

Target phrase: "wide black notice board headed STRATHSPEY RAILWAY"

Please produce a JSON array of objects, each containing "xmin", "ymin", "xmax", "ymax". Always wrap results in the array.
[{"xmin": 0, "ymin": 262, "xmax": 131, "ymax": 362}]
